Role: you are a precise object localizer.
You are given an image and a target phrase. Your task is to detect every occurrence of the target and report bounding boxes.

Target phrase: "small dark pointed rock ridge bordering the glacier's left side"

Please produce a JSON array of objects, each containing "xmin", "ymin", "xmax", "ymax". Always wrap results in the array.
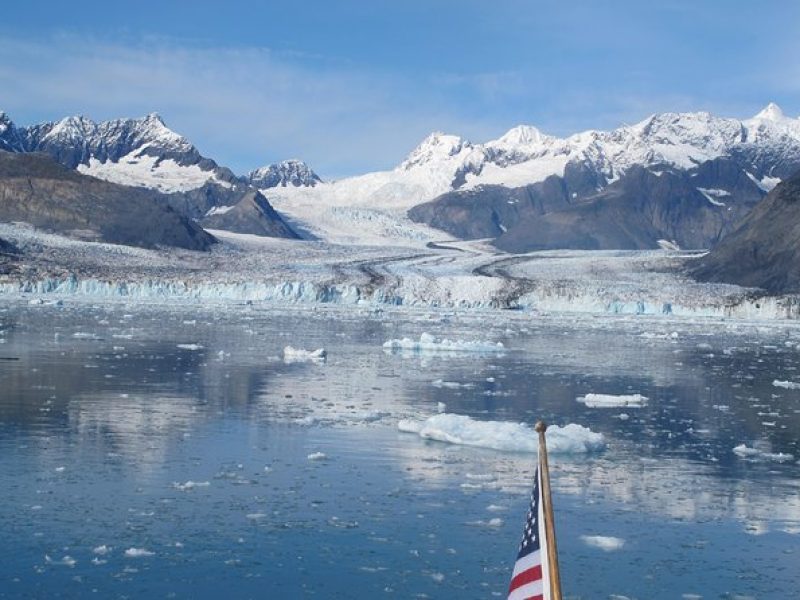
[{"xmin": 201, "ymin": 190, "xmax": 299, "ymax": 239}]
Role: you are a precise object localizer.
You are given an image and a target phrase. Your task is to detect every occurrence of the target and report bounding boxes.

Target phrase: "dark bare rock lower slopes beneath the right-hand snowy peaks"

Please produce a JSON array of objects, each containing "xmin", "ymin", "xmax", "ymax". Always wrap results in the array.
[{"xmin": 409, "ymin": 158, "xmax": 763, "ymax": 252}]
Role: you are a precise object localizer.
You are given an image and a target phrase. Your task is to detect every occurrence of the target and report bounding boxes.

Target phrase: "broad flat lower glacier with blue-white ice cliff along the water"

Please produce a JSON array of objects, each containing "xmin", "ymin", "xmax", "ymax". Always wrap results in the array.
[{"xmin": 0, "ymin": 224, "xmax": 800, "ymax": 322}]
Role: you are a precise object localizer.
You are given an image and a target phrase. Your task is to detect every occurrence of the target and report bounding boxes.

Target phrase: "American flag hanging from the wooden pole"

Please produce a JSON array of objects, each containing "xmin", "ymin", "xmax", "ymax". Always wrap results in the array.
[{"xmin": 508, "ymin": 467, "xmax": 550, "ymax": 600}]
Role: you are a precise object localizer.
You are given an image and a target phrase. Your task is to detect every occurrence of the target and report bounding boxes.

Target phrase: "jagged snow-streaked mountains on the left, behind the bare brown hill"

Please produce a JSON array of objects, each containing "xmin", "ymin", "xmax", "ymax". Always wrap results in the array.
[{"xmin": 0, "ymin": 112, "xmax": 320, "ymax": 237}]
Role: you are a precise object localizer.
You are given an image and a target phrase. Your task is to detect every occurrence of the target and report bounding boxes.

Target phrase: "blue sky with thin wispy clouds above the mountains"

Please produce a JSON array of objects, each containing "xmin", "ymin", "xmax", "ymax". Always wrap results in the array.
[{"xmin": 0, "ymin": 0, "xmax": 800, "ymax": 179}]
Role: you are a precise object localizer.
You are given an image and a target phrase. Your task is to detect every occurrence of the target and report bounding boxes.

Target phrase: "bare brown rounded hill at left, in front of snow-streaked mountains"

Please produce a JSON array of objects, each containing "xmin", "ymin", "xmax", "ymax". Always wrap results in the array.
[{"xmin": 0, "ymin": 152, "xmax": 215, "ymax": 250}]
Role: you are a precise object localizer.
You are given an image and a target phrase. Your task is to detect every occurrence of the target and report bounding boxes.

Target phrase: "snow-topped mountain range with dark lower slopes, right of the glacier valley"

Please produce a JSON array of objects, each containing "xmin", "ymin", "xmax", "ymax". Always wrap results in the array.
[{"xmin": 406, "ymin": 104, "xmax": 800, "ymax": 252}]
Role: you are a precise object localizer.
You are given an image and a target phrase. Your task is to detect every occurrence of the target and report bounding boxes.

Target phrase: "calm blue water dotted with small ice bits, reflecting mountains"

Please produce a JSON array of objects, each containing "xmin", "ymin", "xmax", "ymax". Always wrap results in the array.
[{"xmin": 0, "ymin": 303, "xmax": 800, "ymax": 599}]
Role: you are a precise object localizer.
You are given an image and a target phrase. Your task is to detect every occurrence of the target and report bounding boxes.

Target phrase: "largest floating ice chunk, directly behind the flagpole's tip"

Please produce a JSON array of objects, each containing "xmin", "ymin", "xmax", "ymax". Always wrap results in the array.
[{"xmin": 397, "ymin": 413, "xmax": 605, "ymax": 454}]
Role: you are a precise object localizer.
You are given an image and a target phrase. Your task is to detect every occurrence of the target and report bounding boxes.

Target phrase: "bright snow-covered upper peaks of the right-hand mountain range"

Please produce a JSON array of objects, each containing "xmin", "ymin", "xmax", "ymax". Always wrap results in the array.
[{"xmin": 404, "ymin": 104, "xmax": 800, "ymax": 191}]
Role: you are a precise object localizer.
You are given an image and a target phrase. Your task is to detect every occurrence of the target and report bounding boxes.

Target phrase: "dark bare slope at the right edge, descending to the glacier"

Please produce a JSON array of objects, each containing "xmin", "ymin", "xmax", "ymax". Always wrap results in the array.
[{"xmin": 692, "ymin": 172, "xmax": 800, "ymax": 293}]
